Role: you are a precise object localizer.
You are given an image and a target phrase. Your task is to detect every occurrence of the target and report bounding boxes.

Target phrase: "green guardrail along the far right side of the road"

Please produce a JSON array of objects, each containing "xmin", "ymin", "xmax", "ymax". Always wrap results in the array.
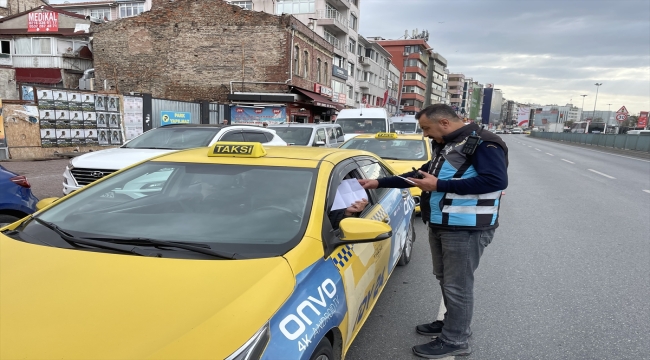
[{"xmin": 530, "ymin": 131, "xmax": 650, "ymax": 152}]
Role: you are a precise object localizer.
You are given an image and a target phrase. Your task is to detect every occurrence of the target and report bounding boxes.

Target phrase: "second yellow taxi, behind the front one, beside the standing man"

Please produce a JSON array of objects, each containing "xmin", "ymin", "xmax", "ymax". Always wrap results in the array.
[{"xmin": 340, "ymin": 133, "xmax": 431, "ymax": 213}]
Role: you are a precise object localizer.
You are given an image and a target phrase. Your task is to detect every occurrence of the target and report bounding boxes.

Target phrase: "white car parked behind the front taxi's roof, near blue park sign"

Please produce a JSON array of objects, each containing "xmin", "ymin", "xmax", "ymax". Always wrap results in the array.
[{"xmin": 63, "ymin": 124, "xmax": 287, "ymax": 195}]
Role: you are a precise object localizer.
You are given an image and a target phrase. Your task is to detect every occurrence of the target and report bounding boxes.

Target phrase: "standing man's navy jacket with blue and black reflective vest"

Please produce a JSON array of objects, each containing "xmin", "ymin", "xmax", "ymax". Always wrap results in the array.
[{"xmin": 379, "ymin": 124, "xmax": 508, "ymax": 230}]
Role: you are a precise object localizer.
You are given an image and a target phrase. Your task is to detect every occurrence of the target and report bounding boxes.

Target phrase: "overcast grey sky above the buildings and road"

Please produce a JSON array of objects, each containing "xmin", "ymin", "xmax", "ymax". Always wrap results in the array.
[{"xmin": 360, "ymin": 0, "xmax": 650, "ymax": 114}]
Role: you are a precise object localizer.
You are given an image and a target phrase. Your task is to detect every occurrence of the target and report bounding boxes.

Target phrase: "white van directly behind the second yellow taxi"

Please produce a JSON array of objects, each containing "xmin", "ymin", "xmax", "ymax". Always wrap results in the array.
[{"xmin": 336, "ymin": 108, "xmax": 395, "ymax": 141}]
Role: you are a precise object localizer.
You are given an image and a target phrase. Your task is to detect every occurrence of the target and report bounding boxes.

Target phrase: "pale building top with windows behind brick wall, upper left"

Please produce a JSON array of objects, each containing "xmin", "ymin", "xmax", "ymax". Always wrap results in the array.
[{"xmin": 52, "ymin": 0, "xmax": 151, "ymax": 21}]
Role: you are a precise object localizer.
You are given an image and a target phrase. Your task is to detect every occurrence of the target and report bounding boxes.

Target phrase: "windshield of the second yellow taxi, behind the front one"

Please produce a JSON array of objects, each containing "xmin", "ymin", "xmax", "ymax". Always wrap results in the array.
[{"xmin": 341, "ymin": 138, "xmax": 427, "ymax": 161}]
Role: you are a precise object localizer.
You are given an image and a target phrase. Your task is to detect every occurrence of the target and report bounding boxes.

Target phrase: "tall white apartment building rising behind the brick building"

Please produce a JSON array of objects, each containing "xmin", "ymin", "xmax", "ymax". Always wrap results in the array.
[{"xmin": 233, "ymin": 0, "xmax": 364, "ymax": 107}]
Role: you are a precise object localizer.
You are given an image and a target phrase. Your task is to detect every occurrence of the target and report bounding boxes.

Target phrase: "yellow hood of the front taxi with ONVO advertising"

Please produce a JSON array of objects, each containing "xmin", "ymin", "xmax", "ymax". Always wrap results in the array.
[{"xmin": 0, "ymin": 238, "xmax": 295, "ymax": 359}]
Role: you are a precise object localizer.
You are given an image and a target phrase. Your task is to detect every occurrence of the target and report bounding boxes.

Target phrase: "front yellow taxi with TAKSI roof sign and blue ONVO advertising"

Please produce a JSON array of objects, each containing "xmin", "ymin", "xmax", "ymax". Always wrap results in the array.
[{"xmin": 0, "ymin": 142, "xmax": 415, "ymax": 360}]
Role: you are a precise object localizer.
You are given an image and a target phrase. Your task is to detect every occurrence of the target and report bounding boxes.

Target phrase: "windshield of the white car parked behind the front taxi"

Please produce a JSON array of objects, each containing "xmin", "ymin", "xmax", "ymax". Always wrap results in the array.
[{"xmin": 123, "ymin": 126, "xmax": 221, "ymax": 149}]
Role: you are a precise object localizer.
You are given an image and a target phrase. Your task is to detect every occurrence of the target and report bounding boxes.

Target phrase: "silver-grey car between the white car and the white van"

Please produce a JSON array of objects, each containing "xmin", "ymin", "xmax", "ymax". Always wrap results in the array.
[{"xmin": 269, "ymin": 123, "xmax": 344, "ymax": 147}]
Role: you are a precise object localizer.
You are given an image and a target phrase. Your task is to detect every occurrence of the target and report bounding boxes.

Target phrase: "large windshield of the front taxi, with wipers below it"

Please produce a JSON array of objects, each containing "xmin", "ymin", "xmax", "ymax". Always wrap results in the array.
[{"xmin": 33, "ymin": 162, "xmax": 316, "ymax": 258}]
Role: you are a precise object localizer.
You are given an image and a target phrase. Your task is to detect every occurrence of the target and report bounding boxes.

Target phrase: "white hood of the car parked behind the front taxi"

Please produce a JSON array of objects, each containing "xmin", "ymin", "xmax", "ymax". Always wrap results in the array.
[{"xmin": 72, "ymin": 148, "xmax": 176, "ymax": 170}]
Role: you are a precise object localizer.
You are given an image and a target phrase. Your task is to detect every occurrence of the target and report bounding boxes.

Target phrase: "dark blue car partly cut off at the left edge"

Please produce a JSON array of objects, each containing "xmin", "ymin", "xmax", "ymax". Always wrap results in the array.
[{"xmin": 0, "ymin": 165, "xmax": 38, "ymax": 228}]
